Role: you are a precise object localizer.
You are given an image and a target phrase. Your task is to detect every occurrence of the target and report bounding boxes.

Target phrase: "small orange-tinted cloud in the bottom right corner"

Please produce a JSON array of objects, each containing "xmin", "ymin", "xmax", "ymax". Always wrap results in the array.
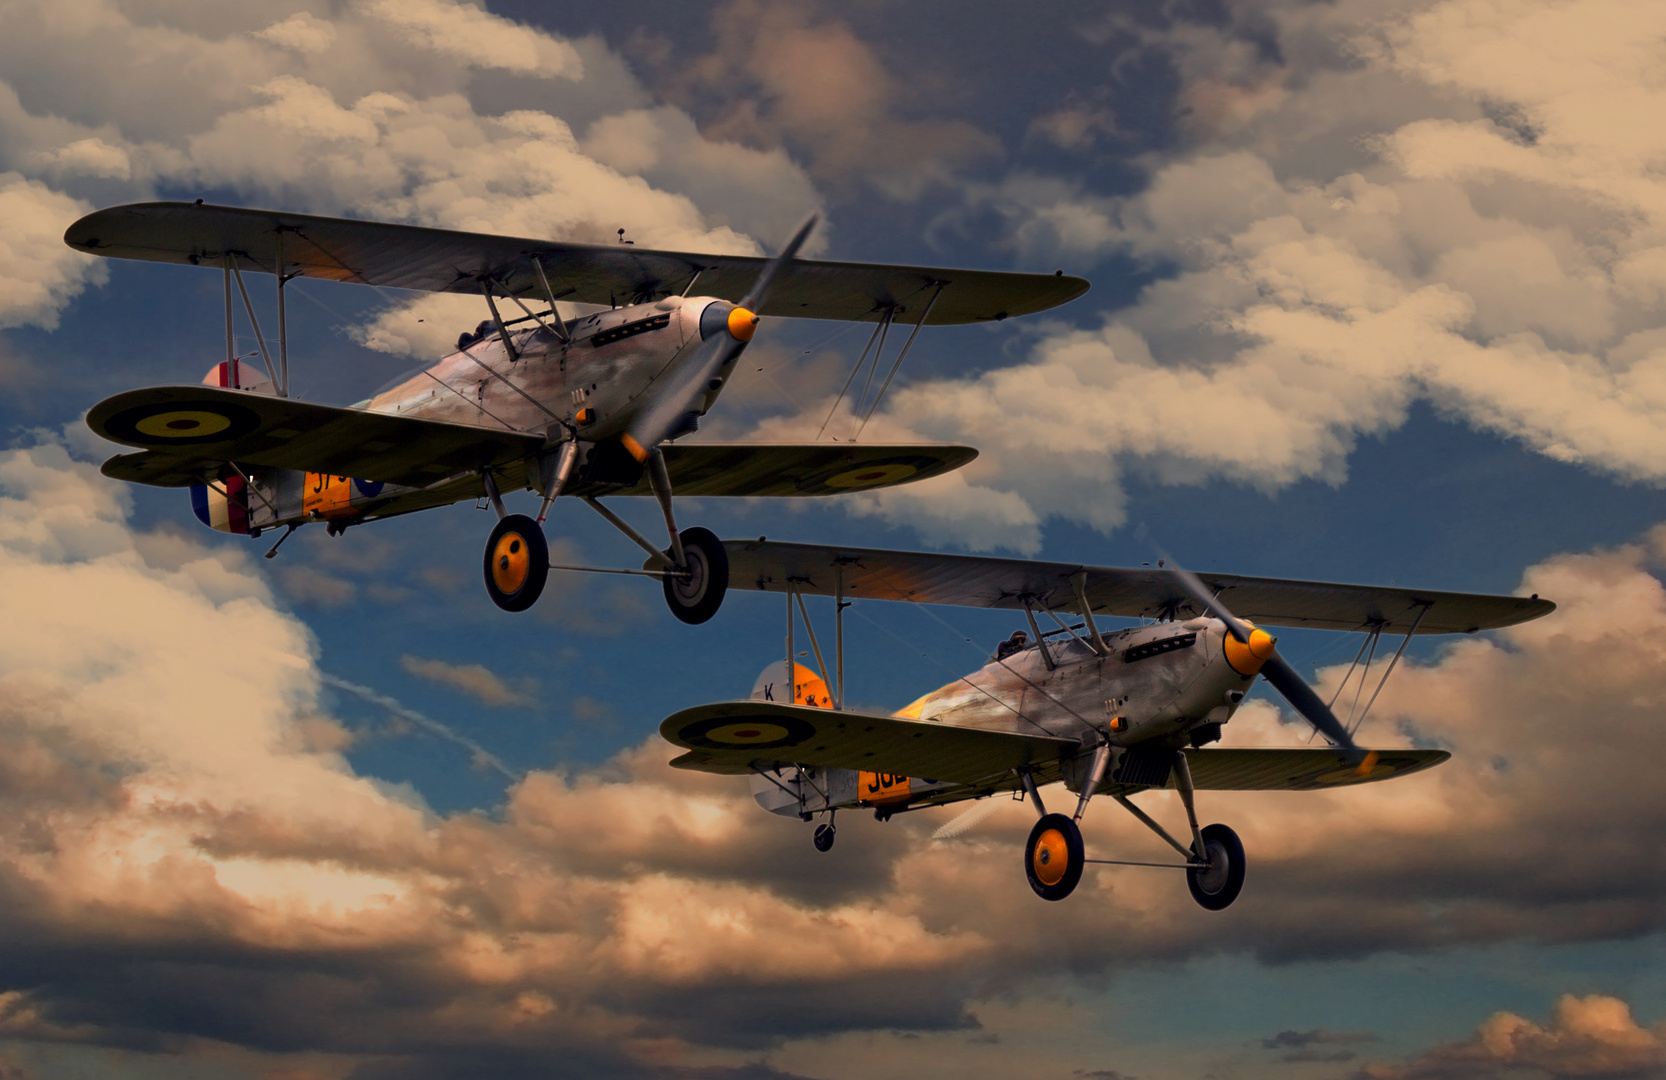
[{"xmin": 1359, "ymin": 993, "xmax": 1666, "ymax": 1080}]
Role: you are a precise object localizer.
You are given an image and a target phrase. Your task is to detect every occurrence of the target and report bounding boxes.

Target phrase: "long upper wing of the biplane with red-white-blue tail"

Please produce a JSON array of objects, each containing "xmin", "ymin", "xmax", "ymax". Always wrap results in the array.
[{"xmin": 63, "ymin": 202, "xmax": 1088, "ymax": 325}]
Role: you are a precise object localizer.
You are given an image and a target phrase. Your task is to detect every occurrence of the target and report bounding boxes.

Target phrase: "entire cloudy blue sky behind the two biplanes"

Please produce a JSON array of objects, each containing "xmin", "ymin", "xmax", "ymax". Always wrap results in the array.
[{"xmin": 0, "ymin": 0, "xmax": 1666, "ymax": 1080}]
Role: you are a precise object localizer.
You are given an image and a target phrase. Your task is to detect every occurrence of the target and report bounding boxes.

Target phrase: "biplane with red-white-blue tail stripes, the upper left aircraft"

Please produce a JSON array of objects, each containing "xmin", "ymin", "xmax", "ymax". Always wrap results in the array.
[{"xmin": 65, "ymin": 200, "xmax": 1088, "ymax": 623}]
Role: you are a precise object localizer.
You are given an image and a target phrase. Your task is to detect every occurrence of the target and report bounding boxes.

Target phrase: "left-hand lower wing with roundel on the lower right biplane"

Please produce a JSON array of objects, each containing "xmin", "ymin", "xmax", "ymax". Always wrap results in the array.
[{"xmin": 660, "ymin": 702, "xmax": 1081, "ymax": 783}]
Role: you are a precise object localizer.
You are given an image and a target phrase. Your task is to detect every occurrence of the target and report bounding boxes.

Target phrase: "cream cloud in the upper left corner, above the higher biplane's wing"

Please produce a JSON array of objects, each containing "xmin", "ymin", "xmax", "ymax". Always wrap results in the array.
[{"xmin": 0, "ymin": 0, "xmax": 820, "ymax": 333}]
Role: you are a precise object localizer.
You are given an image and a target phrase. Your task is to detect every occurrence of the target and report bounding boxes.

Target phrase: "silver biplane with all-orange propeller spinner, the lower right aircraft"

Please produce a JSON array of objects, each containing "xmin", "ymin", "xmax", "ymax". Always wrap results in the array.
[{"xmin": 660, "ymin": 538, "xmax": 1556, "ymax": 910}]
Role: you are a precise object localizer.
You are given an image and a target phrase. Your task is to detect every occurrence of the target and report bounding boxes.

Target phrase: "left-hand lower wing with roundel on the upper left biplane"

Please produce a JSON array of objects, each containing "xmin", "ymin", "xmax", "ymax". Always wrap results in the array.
[{"xmin": 87, "ymin": 387, "xmax": 543, "ymax": 487}]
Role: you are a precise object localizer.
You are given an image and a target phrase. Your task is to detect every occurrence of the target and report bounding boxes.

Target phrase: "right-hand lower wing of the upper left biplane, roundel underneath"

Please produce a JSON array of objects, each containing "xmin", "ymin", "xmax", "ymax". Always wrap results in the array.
[{"xmin": 593, "ymin": 443, "xmax": 978, "ymax": 497}]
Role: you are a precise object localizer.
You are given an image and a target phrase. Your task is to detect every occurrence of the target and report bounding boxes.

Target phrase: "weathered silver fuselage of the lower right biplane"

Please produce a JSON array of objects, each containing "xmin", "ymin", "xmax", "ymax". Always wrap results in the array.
[{"xmin": 751, "ymin": 618, "xmax": 1254, "ymax": 815}]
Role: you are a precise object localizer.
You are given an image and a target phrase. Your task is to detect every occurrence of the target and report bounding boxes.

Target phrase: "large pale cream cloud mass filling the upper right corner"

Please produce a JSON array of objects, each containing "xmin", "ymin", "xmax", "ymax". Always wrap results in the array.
[{"xmin": 829, "ymin": 0, "xmax": 1666, "ymax": 550}]
